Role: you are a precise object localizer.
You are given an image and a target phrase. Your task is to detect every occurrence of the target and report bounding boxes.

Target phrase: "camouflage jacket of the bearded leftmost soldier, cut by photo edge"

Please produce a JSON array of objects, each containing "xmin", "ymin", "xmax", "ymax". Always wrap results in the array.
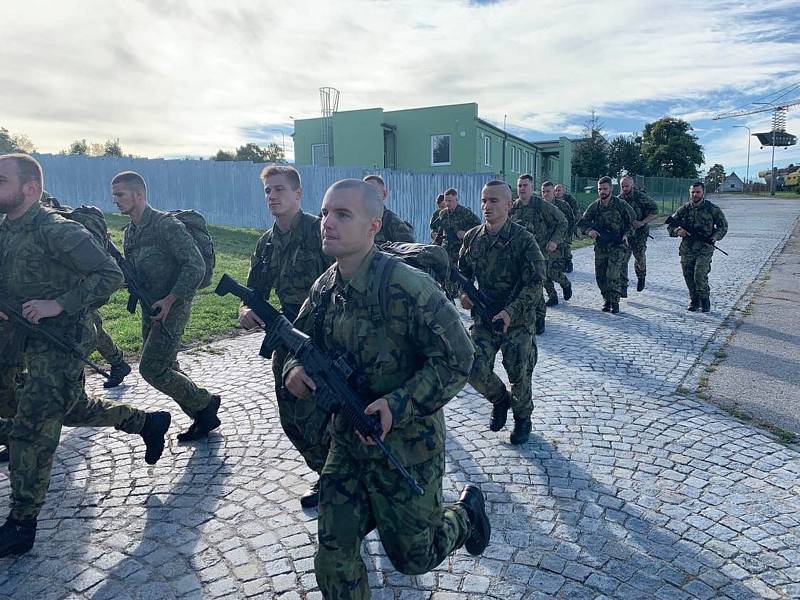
[{"xmin": 0, "ymin": 202, "xmax": 123, "ymax": 351}]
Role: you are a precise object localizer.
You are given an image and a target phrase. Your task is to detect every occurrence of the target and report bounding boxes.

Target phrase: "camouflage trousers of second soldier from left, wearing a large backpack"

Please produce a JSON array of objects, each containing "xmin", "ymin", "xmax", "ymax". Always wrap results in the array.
[{"xmin": 139, "ymin": 300, "xmax": 211, "ymax": 418}]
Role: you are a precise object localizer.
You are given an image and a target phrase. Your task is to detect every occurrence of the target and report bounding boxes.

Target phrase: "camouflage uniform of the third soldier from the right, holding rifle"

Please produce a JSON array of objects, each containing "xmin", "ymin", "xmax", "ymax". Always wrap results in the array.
[{"xmin": 578, "ymin": 196, "xmax": 634, "ymax": 304}]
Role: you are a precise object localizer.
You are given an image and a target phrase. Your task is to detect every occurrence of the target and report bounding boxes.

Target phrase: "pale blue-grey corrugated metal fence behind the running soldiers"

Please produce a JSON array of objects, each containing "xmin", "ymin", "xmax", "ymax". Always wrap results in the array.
[{"xmin": 36, "ymin": 154, "xmax": 494, "ymax": 241}]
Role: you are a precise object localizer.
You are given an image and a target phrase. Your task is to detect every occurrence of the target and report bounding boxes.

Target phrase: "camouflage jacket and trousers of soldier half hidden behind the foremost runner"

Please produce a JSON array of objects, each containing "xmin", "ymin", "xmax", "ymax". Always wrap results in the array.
[{"xmin": 247, "ymin": 210, "xmax": 332, "ymax": 473}]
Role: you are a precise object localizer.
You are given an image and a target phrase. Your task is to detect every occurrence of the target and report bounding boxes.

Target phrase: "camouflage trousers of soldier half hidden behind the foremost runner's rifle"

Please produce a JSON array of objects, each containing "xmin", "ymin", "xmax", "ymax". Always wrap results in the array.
[{"xmin": 272, "ymin": 347, "xmax": 331, "ymax": 473}]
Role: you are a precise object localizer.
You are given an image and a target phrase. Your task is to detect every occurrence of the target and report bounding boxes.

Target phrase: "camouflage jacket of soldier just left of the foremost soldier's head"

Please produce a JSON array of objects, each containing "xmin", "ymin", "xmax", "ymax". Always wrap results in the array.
[{"xmin": 247, "ymin": 210, "xmax": 333, "ymax": 320}]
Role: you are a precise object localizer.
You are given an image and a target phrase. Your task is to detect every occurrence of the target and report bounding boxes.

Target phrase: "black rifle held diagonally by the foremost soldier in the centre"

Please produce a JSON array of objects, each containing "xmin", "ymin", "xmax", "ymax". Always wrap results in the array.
[{"xmin": 214, "ymin": 274, "xmax": 424, "ymax": 496}]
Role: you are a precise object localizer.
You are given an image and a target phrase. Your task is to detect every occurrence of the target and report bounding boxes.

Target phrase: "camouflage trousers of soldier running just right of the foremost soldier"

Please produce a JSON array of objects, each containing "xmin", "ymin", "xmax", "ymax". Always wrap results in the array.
[{"xmin": 469, "ymin": 324, "xmax": 538, "ymax": 420}]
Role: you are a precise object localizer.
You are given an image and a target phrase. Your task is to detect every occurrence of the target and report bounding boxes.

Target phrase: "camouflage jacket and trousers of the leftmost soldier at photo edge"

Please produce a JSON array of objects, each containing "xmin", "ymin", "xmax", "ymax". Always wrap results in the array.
[{"xmin": 0, "ymin": 202, "xmax": 145, "ymax": 519}]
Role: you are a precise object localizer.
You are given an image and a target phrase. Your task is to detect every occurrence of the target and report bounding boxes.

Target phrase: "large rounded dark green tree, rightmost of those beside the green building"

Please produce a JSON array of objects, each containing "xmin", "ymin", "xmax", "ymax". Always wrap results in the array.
[{"xmin": 642, "ymin": 117, "xmax": 705, "ymax": 177}]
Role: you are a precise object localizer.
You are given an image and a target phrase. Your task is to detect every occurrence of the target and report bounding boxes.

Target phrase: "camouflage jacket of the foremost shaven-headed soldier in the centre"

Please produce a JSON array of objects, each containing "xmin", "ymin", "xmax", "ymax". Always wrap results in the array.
[{"xmin": 284, "ymin": 248, "xmax": 474, "ymax": 468}]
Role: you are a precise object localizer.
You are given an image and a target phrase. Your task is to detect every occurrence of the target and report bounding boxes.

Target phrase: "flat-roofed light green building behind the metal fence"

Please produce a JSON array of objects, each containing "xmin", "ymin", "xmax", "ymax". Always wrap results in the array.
[{"xmin": 293, "ymin": 102, "xmax": 572, "ymax": 188}]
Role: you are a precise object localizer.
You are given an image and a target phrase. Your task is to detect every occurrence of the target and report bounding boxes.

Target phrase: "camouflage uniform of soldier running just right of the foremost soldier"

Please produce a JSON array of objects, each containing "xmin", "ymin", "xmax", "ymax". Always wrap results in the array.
[{"xmin": 458, "ymin": 219, "xmax": 545, "ymax": 420}]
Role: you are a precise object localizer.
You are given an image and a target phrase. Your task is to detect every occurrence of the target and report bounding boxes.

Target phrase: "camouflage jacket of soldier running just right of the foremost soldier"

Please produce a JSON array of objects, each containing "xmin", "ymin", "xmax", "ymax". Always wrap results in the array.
[{"xmin": 458, "ymin": 219, "xmax": 544, "ymax": 327}]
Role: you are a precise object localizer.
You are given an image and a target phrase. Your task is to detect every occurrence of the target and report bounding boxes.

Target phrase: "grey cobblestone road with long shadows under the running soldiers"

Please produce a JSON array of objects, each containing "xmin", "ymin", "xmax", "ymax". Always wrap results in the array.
[{"xmin": 0, "ymin": 200, "xmax": 800, "ymax": 600}]
